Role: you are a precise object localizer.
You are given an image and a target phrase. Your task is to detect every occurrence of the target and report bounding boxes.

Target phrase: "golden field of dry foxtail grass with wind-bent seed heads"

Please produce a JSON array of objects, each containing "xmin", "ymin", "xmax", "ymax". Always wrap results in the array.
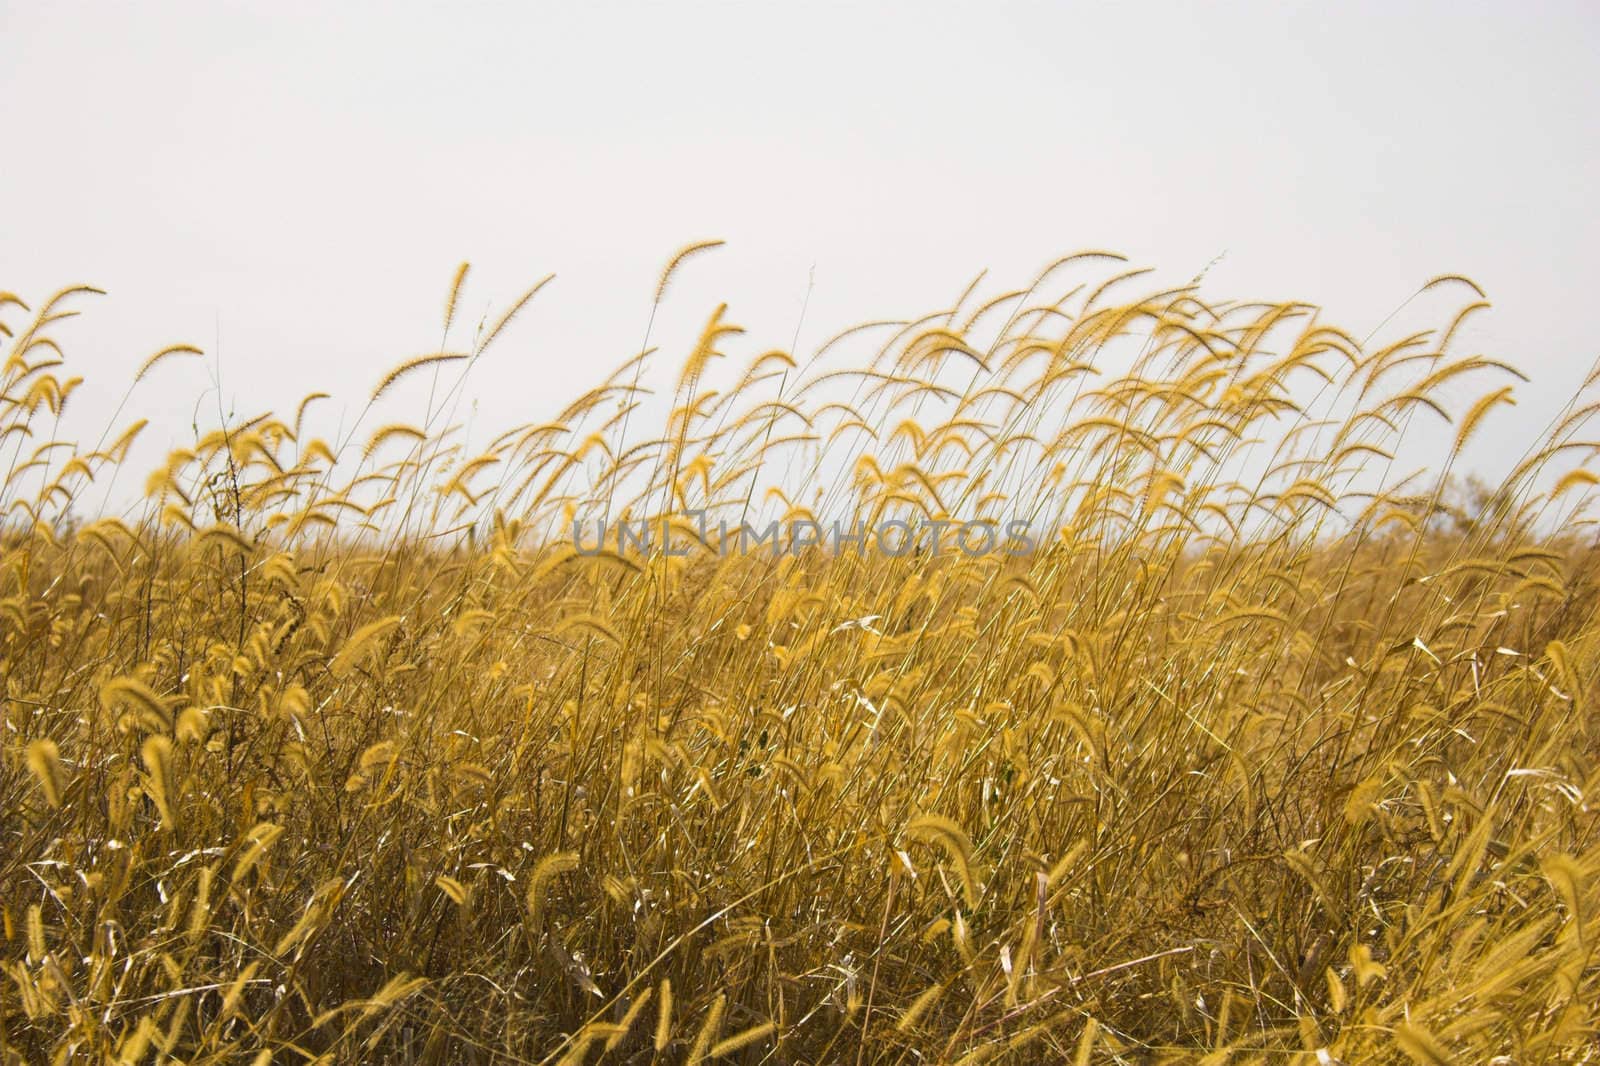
[{"xmin": 0, "ymin": 245, "xmax": 1600, "ymax": 1066}]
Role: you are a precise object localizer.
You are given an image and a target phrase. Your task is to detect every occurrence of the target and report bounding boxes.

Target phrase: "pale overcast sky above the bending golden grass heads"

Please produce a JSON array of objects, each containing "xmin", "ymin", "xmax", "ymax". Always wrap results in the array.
[{"xmin": 0, "ymin": 0, "xmax": 1600, "ymax": 480}]
